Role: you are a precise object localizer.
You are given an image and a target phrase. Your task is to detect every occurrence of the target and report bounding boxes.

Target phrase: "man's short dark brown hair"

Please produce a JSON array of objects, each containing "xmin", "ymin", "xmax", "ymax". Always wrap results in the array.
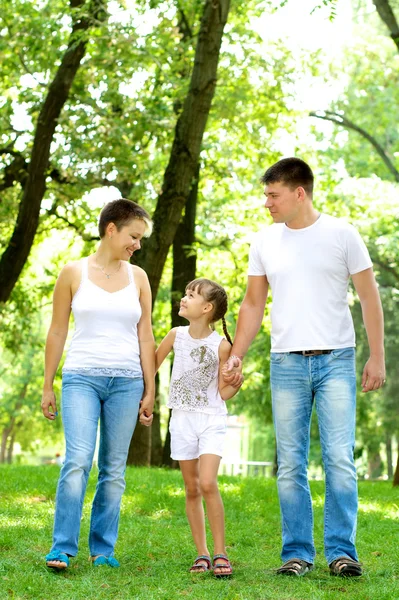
[{"xmin": 260, "ymin": 157, "xmax": 314, "ymax": 196}]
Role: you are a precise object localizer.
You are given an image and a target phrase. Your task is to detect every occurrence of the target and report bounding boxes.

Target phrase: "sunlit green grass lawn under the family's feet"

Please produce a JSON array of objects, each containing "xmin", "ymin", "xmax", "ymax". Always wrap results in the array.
[{"xmin": 0, "ymin": 466, "xmax": 399, "ymax": 600}]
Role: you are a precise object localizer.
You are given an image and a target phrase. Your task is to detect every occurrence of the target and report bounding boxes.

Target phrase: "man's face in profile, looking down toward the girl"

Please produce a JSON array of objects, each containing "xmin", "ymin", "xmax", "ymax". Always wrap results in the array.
[{"xmin": 265, "ymin": 182, "xmax": 305, "ymax": 224}]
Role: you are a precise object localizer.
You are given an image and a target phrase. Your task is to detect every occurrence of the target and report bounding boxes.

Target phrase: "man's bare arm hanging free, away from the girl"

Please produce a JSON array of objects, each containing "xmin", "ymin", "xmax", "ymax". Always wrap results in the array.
[{"xmin": 352, "ymin": 268, "xmax": 385, "ymax": 392}]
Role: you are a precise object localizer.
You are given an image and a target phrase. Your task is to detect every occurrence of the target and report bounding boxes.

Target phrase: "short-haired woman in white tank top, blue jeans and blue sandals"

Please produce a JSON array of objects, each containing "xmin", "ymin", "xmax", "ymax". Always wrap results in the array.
[{"xmin": 42, "ymin": 199, "xmax": 155, "ymax": 570}]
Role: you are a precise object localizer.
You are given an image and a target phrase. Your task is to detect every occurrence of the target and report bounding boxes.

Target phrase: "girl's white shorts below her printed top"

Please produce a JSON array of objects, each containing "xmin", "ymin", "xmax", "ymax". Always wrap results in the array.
[{"xmin": 169, "ymin": 408, "xmax": 227, "ymax": 460}]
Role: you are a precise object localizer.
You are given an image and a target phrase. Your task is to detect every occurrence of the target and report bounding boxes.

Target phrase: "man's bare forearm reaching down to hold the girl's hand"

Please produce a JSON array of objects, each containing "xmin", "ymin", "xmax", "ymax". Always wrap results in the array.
[{"xmin": 223, "ymin": 275, "xmax": 269, "ymax": 383}]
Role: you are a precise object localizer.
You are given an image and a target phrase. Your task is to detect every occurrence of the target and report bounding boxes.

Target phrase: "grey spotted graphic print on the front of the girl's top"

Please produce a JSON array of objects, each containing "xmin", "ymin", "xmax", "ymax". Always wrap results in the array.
[{"xmin": 170, "ymin": 346, "xmax": 219, "ymax": 408}]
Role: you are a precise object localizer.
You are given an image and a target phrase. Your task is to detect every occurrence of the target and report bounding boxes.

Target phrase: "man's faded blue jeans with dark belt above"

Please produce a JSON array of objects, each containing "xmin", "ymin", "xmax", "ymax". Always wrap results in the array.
[{"xmin": 270, "ymin": 348, "xmax": 357, "ymax": 564}]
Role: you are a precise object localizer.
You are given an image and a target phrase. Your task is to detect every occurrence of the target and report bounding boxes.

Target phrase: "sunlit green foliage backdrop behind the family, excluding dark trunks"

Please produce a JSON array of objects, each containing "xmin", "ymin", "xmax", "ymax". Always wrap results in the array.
[{"xmin": 0, "ymin": 0, "xmax": 399, "ymax": 477}]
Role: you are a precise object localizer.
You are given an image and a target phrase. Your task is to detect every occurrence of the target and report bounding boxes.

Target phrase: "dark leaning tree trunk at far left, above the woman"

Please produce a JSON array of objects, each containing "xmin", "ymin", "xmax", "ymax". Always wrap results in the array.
[{"xmin": 0, "ymin": 0, "xmax": 105, "ymax": 302}]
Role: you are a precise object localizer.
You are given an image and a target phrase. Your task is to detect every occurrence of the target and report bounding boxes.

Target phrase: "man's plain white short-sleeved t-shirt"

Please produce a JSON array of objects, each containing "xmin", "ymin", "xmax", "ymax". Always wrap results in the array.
[{"xmin": 248, "ymin": 215, "xmax": 372, "ymax": 352}]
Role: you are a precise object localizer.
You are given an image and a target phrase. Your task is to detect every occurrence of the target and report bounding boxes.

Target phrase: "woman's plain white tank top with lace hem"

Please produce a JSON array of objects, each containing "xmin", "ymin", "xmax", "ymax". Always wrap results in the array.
[{"xmin": 63, "ymin": 258, "xmax": 142, "ymax": 377}]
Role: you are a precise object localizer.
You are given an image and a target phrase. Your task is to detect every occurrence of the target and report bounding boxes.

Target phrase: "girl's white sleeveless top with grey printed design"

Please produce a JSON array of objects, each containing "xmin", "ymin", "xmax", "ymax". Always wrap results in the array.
[{"xmin": 167, "ymin": 326, "xmax": 227, "ymax": 415}]
